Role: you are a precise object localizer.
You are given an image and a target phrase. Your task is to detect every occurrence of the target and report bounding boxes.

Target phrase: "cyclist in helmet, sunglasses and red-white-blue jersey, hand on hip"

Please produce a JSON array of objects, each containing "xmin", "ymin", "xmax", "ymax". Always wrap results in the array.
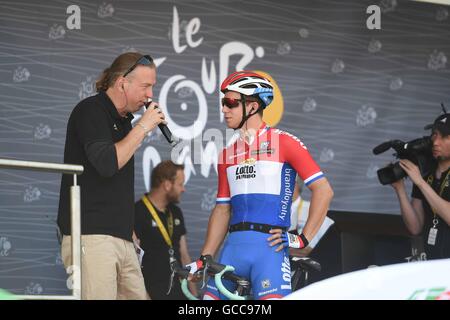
[{"xmin": 188, "ymin": 71, "xmax": 333, "ymax": 299}]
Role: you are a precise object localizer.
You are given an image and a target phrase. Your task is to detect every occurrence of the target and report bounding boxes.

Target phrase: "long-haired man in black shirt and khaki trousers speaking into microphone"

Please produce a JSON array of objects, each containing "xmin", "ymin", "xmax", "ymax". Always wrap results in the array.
[{"xmin": 58, "ymin": 52, "xmax": 166, "ymax": 299}]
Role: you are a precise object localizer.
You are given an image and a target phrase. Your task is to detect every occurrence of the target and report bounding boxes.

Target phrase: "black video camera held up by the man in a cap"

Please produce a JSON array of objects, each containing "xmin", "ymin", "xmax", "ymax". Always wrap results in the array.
[{"xmin": 373, "ymin": 136, "xmax": 433, "ymax": 185}]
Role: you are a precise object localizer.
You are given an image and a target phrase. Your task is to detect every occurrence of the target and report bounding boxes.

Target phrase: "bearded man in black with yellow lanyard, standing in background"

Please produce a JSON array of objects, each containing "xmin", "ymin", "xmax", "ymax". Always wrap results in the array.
[{"xmin": 134, "ymin": 160, "xmax": 197, "ymax": 300}]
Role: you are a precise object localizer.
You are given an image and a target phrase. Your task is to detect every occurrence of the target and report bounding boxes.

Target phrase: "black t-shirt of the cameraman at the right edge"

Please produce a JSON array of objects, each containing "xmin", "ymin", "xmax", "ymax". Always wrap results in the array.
[{"xmin": 411, "ymin": 168, "xmax": 450, "ymax": 259}]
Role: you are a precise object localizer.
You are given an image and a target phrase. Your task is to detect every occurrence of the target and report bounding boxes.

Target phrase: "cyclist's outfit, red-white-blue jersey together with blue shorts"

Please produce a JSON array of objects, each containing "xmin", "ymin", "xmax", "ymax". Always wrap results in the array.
[{"xmin": 205, "ymin": 123, "xmax": 323, "ymax": 299}]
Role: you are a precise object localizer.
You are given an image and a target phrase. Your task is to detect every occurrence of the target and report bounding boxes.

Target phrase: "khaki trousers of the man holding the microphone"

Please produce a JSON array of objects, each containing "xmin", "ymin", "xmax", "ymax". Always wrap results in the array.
[{"xmin": 61, "ymin": 234, "xmax": 147, "ymax": 300}]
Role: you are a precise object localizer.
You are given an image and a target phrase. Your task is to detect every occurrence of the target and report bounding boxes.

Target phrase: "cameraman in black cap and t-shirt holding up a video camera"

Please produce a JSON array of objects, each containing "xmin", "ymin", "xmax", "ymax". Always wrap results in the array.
[{"xmin": 392, "ymin": 113, "xmax": 450, "ymax": 260}]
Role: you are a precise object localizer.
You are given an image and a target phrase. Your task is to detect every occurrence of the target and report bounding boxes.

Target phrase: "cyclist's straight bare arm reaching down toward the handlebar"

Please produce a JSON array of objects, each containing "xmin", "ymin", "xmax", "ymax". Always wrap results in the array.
[{"xmin": 202, "ymin": 204, "xmax": 231, "ymax": 256}]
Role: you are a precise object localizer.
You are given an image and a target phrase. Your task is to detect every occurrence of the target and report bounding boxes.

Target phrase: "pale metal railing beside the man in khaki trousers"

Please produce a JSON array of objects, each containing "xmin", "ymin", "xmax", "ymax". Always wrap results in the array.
[{"xmin": 0, "ymin": 159, "xmax": 84, "ymax": 300}]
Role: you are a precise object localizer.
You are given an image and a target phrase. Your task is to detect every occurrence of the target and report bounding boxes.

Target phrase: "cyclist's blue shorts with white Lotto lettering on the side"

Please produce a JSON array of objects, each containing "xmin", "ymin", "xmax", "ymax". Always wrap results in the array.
[{"xmin": 204, "ymin": 231, "xmax": 291, "ymax": 300}]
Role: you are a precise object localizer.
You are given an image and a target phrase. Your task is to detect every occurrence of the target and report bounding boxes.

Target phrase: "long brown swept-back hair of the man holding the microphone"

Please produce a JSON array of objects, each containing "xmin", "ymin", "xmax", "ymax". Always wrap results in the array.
[{"xmin": 95, "ymin": 52, "xmax": 155, "ymax": 92}]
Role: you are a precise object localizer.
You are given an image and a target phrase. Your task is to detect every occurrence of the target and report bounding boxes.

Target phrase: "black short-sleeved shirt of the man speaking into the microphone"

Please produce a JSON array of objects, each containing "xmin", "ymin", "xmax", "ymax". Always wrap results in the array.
[{"xmin": 58, "ymin": 92, "xmax": 134, "ymax": 241}]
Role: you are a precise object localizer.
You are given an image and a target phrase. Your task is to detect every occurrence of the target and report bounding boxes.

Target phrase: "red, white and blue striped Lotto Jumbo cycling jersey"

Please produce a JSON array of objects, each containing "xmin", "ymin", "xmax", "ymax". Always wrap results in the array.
[{"xmin": 216, "ymin": 123, "xmax": 324, "ymax": 228}]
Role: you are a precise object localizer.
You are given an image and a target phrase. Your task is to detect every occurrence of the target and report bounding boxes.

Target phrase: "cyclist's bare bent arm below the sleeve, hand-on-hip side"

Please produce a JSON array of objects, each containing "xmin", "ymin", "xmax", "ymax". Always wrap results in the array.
[{"xmin": 303, "ymin": 177, "xmax": 334, "ymax": 241}]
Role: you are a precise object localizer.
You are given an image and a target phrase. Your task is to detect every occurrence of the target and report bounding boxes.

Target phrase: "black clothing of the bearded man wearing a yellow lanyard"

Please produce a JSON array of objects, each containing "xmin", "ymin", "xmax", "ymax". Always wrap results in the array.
[{"xmin": 134, "ymin": 199, "xmax": 186, "ymax": 299}]
